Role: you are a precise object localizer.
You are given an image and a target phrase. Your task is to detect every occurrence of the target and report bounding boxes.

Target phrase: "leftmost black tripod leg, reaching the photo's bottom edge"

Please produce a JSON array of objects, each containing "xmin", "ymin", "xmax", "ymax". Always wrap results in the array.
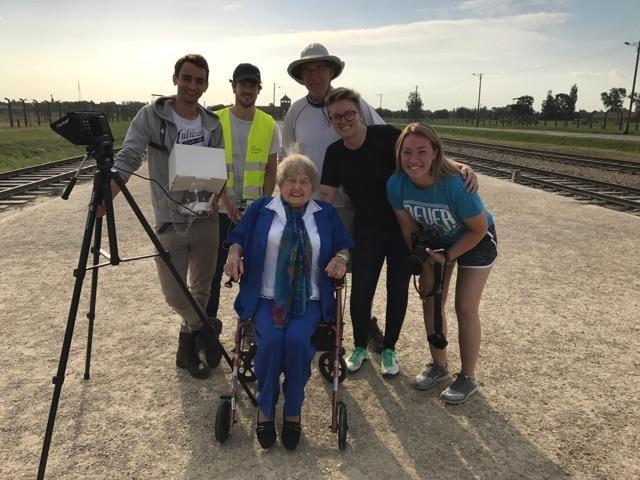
[{"xmin": 37, "ymin": 171, "xmax": 104, "ymax": 480}]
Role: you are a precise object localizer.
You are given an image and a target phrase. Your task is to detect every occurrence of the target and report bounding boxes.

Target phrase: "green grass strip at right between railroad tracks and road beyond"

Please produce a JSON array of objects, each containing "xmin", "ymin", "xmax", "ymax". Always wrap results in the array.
[{"xmin": 396, "ymin": 125, "xmax": 640, "ymax": 162}]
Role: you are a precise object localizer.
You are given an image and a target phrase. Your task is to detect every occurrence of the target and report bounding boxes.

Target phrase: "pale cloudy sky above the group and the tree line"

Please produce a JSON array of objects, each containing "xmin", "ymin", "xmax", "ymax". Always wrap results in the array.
[{"xmin": 0, "ymin": 0, "xmax": 640, "ymax": 111}]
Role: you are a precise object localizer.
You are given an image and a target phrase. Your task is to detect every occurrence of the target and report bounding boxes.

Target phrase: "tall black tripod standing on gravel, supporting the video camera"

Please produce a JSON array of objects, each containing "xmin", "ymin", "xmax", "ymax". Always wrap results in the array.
[{"xmin": 37, "ymin": 140, "xmax": 257, "ymax": 480}]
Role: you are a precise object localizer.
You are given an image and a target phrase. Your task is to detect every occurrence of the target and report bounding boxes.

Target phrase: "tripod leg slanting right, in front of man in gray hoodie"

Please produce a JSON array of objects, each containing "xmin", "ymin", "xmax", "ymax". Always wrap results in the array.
[{"xmin": 113, "ymin": 175, "xmax": 258, "ymax": 406}]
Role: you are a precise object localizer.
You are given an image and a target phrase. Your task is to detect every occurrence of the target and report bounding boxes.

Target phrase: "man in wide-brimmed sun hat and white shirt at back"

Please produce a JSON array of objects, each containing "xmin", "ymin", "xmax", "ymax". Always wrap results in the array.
[{"xmin": 282, "ymin": 43, "xmax": 385, "ymax": 352}]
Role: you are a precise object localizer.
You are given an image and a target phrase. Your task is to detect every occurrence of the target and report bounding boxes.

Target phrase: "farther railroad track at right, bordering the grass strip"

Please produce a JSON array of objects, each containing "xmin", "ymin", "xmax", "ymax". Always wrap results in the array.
[{"xmin": 444, "ymin": 139, "xmax": 640, "ymax": 174}]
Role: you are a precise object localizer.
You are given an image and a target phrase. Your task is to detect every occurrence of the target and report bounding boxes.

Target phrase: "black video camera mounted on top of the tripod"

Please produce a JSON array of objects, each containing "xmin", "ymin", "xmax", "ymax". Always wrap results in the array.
[{"xmin": 51, "ymin": 112, "xmax": 113, "ymax": 146}]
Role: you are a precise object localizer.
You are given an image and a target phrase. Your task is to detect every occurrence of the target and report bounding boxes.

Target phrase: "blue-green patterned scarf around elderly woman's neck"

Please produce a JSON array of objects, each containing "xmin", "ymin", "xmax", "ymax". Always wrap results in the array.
[{"xmin": 273, "ymin": 200, "xmax": 311, "ymax": 328}]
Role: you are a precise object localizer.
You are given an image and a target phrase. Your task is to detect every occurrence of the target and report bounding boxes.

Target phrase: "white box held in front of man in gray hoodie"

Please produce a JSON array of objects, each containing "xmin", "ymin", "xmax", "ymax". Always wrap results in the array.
[{"xmin": 169, "ymin": 143, "xmax": 227, "ymax": 194}]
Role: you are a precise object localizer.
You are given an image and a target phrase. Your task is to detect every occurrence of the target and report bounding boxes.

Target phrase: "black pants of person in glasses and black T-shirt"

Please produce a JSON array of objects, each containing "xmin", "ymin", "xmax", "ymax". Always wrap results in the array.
[{"xmin": 350, "ymin": 225, "xmax": 411, "ymax": 349}]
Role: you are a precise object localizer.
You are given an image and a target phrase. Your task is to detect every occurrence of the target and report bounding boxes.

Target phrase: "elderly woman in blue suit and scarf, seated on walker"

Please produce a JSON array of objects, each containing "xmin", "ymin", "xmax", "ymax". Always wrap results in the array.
[{"xmin": 224, "ymin": 155, "xmax": 353, "ymax": 450}]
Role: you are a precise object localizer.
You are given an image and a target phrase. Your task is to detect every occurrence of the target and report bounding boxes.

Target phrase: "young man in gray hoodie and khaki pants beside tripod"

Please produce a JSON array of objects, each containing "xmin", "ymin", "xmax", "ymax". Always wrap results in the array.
[{"xmin": 113, "ymin": 54, "xmax": 224, "ymax": 378}]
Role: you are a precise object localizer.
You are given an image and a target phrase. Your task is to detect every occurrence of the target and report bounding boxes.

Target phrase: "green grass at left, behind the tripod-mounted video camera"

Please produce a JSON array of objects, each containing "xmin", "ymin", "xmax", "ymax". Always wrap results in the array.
[{"xmin": 0, "ymin": 121, "xmax": 129, "ymax": 172}]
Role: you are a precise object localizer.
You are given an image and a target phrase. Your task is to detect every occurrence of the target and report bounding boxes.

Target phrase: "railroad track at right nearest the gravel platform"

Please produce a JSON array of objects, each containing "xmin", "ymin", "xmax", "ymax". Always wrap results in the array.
[{"xmin": 451, "ymin": 153, "xmax": 640, "ymax": 215}]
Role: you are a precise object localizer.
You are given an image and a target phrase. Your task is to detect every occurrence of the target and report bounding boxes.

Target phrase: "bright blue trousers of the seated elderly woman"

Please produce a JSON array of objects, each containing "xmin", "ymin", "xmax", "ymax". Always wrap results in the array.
[{"xmin": 254, "ymin": 298, "xmax": 321, "ymax": 420}]
